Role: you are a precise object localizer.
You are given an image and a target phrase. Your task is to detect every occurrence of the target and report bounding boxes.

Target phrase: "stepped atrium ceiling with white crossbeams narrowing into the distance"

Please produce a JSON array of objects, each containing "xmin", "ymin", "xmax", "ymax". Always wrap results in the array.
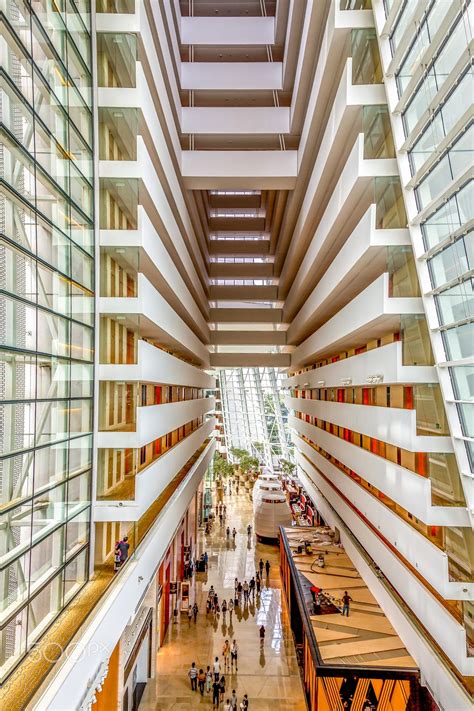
[{"xmin": 156, "ymin": 0, "xmax": 336, "ymax": 367}]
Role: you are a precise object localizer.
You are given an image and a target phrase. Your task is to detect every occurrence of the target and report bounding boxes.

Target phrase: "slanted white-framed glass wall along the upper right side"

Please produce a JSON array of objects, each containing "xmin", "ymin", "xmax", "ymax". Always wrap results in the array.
[{"xmin": 391, "ymin": 0, "xmax": 474, "ymax": 470}]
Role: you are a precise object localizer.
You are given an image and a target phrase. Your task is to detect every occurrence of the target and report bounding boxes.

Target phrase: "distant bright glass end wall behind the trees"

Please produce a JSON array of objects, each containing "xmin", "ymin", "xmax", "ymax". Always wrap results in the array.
[{"xmin": 219, "ymin": 368, "xmax": 290, "ymax": 467}]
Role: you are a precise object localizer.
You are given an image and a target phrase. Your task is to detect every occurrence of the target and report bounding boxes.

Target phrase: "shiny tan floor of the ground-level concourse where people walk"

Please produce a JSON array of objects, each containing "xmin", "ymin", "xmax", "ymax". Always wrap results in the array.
[{"xmin": 140, "ymin": 488, "xmax": 306, "ymax": 711}]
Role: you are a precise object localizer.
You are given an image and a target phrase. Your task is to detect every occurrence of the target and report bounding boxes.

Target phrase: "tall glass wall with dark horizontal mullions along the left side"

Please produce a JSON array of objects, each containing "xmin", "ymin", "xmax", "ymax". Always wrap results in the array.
[{"xmin": 0, "ymin": 0, "xmax": 94, "ymax": 682}]
